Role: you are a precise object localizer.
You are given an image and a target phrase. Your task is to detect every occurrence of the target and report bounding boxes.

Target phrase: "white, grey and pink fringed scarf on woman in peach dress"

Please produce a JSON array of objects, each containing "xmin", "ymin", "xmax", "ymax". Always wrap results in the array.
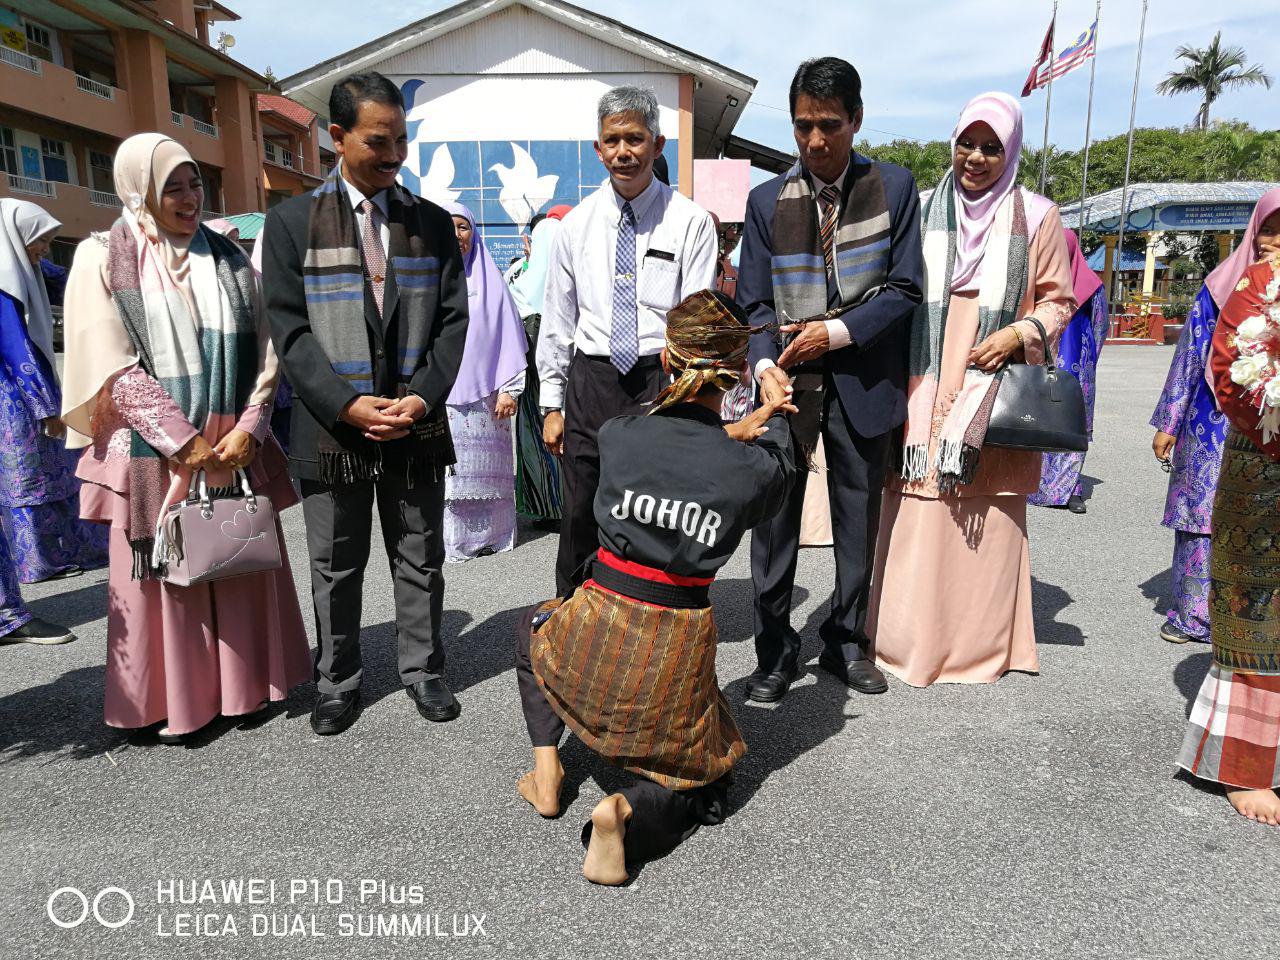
[{"xmin": 901, "ymin": 173, "xmax": 1029, "ymax": 493}]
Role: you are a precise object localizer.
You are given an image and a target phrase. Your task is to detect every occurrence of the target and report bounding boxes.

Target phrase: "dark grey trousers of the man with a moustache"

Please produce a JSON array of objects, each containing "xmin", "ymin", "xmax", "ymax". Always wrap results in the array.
[{"xmin": 302, "ymin": 475, "xmax": 444, "ymax": 694}]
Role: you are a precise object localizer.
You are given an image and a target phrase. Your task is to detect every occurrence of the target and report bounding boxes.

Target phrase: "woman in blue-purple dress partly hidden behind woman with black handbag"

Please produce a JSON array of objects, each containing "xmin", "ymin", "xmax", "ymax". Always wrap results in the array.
[{"xmin": 1027, "ymin": 230, "xmax": 1111, "ymax": 513}]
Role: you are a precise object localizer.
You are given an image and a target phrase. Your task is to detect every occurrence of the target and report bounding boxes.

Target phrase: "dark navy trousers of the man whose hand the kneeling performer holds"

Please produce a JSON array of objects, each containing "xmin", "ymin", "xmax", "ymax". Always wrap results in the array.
[{"xmin": 751, "ymin": 376, "xmax": 891, "ymax": 673}]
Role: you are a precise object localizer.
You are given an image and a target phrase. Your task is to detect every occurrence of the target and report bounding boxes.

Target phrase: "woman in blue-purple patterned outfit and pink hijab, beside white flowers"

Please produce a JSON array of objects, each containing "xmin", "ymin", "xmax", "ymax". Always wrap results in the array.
[{"xmin": 1151, "ymin": 188, "xmax": 1280, "ymax": 644}]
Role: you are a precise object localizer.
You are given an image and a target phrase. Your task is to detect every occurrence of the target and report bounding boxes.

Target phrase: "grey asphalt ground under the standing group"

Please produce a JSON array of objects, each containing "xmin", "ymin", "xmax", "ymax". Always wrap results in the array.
[{"xmin": 0, "ymin": 347, "xmax": 1280, "ymax": 960}]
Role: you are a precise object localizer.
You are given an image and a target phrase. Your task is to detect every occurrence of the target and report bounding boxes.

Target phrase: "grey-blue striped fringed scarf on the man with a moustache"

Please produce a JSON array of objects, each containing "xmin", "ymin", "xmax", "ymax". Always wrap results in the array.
[{"xmin": 302, "ymin": 165, "xmax": 456, "ymax": 484}]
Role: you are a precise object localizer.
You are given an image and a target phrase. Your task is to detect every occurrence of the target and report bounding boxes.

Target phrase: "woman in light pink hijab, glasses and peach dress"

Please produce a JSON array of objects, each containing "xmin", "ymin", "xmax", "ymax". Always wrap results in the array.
[{"xmin": 868, "ymin": 93, "xmax": 1075, "ymax": 686}]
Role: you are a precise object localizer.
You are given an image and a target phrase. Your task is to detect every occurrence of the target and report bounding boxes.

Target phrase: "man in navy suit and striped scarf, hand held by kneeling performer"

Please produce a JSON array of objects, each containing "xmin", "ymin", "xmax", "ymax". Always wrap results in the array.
[{"xmin": 737, "ymin": 58, "xmax": 924, "ymax": 703}]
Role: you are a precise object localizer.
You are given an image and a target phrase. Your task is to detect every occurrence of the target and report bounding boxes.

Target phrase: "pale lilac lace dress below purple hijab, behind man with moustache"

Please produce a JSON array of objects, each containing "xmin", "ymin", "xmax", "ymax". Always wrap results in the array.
[{"xmin": 444, "ymin": 397, "xmax": 516, "ymax": 562}]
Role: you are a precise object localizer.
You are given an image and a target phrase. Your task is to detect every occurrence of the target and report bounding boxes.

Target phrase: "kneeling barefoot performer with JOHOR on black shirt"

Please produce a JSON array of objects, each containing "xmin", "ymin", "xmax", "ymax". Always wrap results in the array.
[{"xmin": 516, "ymin": 291, "xmax": 795, "ymax": 884}]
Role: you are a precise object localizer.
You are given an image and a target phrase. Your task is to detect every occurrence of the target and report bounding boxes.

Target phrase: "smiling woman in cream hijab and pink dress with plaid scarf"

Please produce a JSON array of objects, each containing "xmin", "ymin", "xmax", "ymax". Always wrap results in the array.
[{"xmin": 63, "ymin": 133, "xmax": 311, "ymax": 742}]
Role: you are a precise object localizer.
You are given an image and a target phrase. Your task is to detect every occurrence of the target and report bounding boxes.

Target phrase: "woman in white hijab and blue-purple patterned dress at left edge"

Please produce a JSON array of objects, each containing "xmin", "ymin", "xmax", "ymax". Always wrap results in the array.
[{"xmin": 0, "ymin": 198, "xmax": 106, "ymax": 584}]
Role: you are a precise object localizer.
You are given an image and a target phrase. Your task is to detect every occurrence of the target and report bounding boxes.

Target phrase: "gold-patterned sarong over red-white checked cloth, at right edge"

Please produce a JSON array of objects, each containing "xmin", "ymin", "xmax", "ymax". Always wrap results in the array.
[{"xmin": 1178, "ymin": 430, "xmax": 1280, "ymax": 790}]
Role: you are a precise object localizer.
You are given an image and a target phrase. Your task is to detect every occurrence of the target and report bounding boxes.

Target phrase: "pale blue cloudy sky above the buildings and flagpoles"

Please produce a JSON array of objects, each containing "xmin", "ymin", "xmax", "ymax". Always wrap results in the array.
[{"xmin": 220, "ymin": 0, "xmax": 1280, "ymax": 151}]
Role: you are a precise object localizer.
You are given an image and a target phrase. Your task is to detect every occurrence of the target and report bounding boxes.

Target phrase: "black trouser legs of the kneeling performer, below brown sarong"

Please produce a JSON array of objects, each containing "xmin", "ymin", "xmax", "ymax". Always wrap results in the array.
[{"xmin": 516, "ymin": 608, "xmax": 733, "ymax": 864}]
